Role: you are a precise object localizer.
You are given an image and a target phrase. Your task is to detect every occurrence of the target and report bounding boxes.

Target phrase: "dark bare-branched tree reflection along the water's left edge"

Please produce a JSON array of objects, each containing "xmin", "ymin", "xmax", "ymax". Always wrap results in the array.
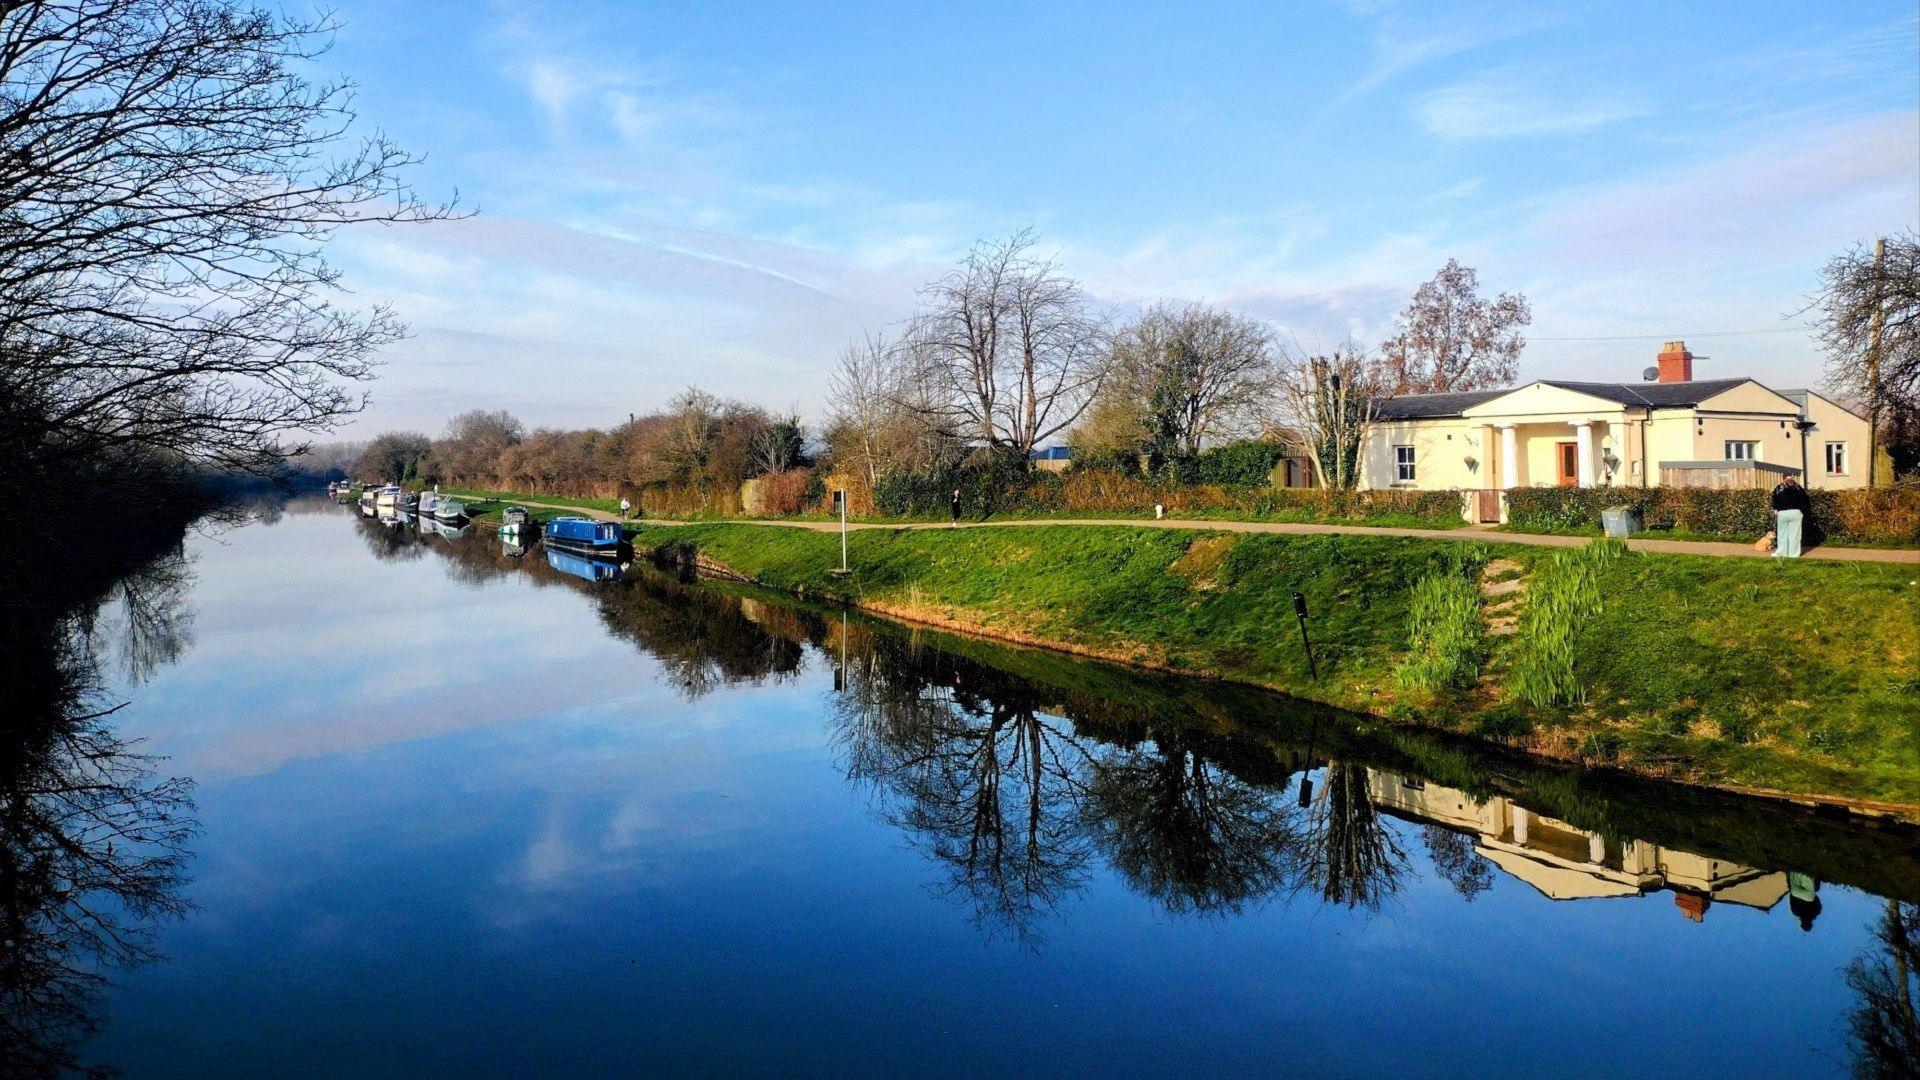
[{"xmin": 0, "ymin": 548, "xmax": 196, "ymax": 1074}]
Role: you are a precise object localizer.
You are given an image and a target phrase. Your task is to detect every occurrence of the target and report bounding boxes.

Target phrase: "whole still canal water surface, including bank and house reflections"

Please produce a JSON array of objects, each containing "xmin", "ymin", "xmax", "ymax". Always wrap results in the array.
[{"xmin": 8, "ymin": 502, "xmax": 1920, "ymax": 1076}]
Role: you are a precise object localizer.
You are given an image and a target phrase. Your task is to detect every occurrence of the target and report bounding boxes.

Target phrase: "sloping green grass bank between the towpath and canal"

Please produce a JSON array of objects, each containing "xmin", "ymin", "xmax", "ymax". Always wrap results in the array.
[{"xmin": 634, "ymin": 523, "xmax": 1920, "ymax": 807}]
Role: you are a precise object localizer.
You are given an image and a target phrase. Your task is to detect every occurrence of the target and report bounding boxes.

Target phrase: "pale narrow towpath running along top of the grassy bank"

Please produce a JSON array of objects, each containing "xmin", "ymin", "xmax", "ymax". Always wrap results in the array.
[{"xmin": 456, "ymin": 500, "xmax": 1920, "ymax": 565}]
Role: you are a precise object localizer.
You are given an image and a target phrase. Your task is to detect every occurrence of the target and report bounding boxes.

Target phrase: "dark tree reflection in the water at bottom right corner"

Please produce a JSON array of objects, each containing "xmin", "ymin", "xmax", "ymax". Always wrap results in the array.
[{"xmin": 1847, "ymin": 899, "xmax": 1920, "ymax": 1080}]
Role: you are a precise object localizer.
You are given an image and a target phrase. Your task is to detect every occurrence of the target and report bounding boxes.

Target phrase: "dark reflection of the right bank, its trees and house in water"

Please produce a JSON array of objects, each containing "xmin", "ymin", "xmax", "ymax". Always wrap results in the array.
[{"xmin": 376, "ymin": 511, "xmax": 1920, "ymax": 944}]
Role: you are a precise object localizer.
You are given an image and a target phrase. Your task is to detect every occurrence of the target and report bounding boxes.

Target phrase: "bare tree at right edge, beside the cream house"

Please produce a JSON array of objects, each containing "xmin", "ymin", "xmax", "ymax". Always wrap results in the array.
[{"xmin": 1814, "ymin": 233, "xmax": 1920, "ymax": 488}]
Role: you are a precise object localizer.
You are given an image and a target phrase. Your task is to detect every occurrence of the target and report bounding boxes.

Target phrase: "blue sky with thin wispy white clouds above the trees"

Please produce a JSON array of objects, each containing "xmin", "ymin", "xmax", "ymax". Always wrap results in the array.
[{"xmin": 326, "ymin": 0, "xmax": 1920, "ymax": 436}]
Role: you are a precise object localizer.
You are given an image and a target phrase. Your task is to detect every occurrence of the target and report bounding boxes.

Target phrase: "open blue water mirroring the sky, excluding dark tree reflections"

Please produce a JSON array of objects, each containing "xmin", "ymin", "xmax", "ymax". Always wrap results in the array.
[{"xmin": 92, "ymin": 513, "xmax": 1880, "ymax": 1076}]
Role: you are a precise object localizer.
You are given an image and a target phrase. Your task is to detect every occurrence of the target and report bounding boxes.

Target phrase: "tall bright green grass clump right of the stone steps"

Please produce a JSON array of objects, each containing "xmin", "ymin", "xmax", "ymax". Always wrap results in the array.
[{"xmin": 1507, "ymin": 538, "xmax": 1626, "ymax": 707}]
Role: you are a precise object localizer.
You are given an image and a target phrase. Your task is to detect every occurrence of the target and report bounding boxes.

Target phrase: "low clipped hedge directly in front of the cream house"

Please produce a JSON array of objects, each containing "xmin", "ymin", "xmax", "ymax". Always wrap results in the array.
[{"xmin": 1507, "ymin": 488, "xmax": 1920, "ymax": 546}]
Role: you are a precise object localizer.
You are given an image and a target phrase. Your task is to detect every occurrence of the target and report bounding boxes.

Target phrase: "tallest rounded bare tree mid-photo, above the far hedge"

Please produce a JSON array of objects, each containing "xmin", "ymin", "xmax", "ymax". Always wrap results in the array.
[{"xmin": 897, "ymin": 229, "xmax": 1106, "ymax": 455}]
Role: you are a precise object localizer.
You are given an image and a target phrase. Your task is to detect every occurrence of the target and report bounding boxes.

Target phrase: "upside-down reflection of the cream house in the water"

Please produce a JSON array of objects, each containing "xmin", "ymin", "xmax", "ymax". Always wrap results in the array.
[{"xmin": 1371, "ymin": 771, "xmax": 1818, "ymax": 928}]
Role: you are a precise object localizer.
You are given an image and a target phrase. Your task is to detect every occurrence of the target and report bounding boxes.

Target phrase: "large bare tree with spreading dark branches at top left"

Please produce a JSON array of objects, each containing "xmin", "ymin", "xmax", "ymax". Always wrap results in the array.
[{"xmin": 0, "ymin": 0, "xmax": 449, "ymax": 469}]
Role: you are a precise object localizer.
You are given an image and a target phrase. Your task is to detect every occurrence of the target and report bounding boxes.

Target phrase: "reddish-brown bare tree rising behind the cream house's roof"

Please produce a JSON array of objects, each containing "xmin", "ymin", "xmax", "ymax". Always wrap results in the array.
[{"xmin": 1380, "ymin": 259, "xmax": 1534, "ymax": 394}]
